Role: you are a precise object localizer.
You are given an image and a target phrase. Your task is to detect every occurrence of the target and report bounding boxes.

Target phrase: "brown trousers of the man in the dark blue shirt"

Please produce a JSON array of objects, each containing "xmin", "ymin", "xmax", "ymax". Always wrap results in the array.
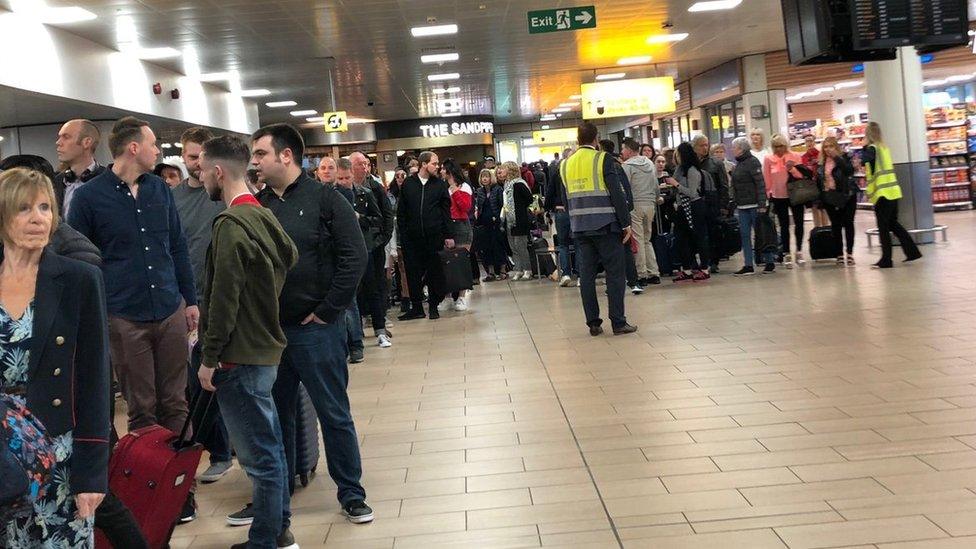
[{"xmin": 108, "ymin": 304, "xmax": 189, "ymax": 433}]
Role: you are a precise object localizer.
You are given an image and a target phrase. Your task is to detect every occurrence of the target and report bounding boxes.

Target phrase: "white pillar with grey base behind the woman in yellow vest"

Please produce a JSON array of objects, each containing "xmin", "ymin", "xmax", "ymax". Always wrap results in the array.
[{"xmin": 864, "ymin": 47, "xmax": 935, "ymax": 243}]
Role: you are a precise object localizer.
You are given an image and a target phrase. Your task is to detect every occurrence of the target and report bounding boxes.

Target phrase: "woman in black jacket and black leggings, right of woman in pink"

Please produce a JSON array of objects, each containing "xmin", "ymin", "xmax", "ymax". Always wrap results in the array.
[{"xmin": 820, "ymin": 137, "xmax": 860, "ymax": 265}]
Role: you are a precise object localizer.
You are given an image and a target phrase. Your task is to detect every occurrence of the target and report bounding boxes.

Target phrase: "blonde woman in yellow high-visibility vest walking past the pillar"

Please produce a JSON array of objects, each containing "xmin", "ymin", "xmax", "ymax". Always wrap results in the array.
[{"xmin": 861, "ymin": 122, "xmax": 922, "ymax": 269}]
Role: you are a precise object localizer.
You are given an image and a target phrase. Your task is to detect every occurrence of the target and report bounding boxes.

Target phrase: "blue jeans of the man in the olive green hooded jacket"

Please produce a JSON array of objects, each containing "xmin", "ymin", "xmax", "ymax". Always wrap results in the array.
[{"xmin": 214, "ymin": 364, "xmax": 286, "ymax": 549}]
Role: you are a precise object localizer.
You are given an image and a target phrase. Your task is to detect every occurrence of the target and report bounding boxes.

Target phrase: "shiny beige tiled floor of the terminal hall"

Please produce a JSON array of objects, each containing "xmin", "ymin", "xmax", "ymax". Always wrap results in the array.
[{"xmin": 174, "ymin": 208, "xmax": 976, "ymax": 549}]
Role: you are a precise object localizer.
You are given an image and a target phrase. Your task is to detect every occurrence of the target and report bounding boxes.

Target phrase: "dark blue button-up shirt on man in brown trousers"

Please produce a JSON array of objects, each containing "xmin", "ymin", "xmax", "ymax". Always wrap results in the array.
[{"xmin": 67, "ymin": 166, "xmax": 197, "ymax": 322}]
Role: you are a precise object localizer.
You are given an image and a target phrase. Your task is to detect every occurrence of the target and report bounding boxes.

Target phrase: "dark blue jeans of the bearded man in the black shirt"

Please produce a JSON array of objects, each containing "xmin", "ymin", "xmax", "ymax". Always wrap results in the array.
[{"xmin": 274, "ymin": 319, "xmax": 366, "ymax": 505}]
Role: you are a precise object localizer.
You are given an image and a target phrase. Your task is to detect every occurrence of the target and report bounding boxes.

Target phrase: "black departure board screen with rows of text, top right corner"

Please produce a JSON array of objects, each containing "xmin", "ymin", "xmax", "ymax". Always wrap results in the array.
[{"xmin": 850, "ymin": 0, "xmax": 969, "ymax": 50}]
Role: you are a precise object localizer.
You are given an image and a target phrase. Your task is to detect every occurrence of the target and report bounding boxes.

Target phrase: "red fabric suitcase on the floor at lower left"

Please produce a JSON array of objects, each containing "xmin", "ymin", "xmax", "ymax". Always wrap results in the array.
[{"xmin": 96, "ymin": 391, "xmax": 213, "ymax": 549}]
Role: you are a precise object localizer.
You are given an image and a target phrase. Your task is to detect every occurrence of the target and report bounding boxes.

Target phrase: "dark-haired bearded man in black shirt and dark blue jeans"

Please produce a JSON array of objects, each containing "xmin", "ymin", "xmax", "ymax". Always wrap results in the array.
[{"xmin": 251, "ymin": 124, "xmax": 373, "ymax": 523}]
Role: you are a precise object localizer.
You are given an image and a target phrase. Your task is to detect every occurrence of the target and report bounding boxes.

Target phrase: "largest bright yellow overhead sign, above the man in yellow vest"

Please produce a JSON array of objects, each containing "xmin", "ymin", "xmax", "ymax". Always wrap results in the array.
[{"xmin": 581, "ymin": 76, "xmax": 675, "ymax": 120}]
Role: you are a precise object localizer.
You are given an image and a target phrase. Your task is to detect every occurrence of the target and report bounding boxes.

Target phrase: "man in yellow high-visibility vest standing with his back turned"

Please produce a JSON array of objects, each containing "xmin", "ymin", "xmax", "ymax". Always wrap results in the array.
[{"xmin": 553, "ymin": 122, "xmax": 637, "ymax": 336}]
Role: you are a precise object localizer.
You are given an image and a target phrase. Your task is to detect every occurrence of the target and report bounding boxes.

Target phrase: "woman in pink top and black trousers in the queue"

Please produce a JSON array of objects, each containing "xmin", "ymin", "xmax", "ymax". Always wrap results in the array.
[{"xmin": 763, "ymin": 134, "xmax": 805, "ymax": 269}]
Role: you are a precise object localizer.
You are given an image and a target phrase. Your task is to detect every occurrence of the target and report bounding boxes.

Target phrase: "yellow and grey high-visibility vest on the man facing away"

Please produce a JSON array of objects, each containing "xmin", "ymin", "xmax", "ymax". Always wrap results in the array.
[{"xmin": 559, "ymin": 148, "xmax": 616, "ymax": 232}]
